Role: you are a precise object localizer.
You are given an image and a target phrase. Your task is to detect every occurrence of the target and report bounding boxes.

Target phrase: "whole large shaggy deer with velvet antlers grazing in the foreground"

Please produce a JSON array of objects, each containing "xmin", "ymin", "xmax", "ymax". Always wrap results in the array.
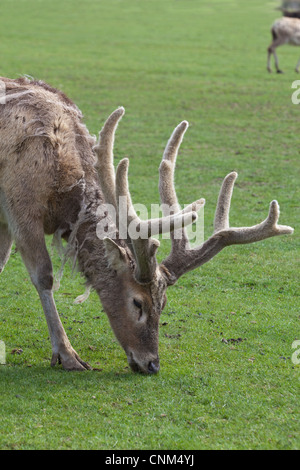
[{"xmin": 0, "ymin": 78, "xmax": 293, "ymax": 373}]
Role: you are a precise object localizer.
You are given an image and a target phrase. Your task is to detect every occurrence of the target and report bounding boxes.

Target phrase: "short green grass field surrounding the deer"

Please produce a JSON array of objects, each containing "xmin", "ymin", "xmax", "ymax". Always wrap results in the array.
[{"xmin": 0, "ymin": 0, "xmax": 300, "ymax": 450}]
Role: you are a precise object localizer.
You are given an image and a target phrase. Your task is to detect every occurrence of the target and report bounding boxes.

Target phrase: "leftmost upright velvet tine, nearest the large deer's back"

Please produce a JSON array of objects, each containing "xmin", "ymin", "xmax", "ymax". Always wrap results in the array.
[{"xmin": 94, "ymin": 107, "xmax": 125, "ymax": 210}]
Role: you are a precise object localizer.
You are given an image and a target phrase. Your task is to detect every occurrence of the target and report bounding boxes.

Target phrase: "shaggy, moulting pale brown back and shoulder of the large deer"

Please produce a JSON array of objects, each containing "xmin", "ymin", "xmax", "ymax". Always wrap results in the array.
[{"xmin": 0, "ymin": 78, "xmax": 99, "ymax": 237}]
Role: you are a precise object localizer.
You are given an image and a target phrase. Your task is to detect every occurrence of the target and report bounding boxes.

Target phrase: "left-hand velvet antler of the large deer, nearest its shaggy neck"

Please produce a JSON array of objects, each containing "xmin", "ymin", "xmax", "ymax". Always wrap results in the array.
[{"xmin": 94, "ymin": 108, "xmax": 199, "ymax": 283}]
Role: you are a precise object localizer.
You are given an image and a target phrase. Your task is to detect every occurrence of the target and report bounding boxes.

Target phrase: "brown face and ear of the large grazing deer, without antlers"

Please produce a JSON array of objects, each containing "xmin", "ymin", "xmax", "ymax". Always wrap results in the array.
[{"xmin": 102, "ymin": 239, "xmax": 167, "ymax": 374}]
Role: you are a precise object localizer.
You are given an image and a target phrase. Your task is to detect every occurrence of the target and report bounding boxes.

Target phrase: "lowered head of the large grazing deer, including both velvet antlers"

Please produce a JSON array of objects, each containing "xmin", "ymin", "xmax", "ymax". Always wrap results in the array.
[{"xmin": 94, "ymin": 108, "xmax": 293, "ymax": 373}]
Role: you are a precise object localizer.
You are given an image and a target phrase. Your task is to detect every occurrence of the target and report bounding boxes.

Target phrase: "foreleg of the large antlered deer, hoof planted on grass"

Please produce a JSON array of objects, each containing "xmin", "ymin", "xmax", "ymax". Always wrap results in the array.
[{"xmin": 16, "ymin": 231, "xmax": 91, "ymax": 370}]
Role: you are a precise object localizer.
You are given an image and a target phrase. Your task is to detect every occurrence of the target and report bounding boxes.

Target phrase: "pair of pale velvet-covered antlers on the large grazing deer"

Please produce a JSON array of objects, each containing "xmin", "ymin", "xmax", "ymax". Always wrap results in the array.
[{"xmin": 94, "ymin": 108, "xmax": 293, "ymax": 284}]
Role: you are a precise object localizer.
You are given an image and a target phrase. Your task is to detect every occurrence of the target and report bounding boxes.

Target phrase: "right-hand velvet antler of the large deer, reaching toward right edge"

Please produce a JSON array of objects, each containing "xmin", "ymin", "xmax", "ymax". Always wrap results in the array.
[{"xmin": 159, "ymin": 121, "xmax": 294, "ymax": 284}]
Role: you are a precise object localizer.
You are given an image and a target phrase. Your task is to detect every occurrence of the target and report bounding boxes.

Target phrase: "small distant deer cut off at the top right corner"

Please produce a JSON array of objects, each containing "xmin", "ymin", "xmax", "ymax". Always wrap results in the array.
[{"xmin": 267, "ymin": 16, "xmax": 300, "ymax": 73}]
